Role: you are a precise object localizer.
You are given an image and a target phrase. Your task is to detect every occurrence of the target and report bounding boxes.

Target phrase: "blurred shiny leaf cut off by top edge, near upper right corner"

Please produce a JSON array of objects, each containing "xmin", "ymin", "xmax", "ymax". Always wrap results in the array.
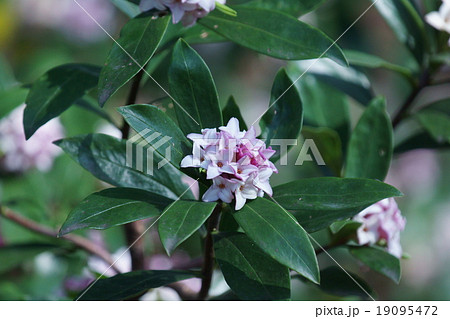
[{"xmin": 372, "ymin": 0, "xmax": 427, "ymax": 65}]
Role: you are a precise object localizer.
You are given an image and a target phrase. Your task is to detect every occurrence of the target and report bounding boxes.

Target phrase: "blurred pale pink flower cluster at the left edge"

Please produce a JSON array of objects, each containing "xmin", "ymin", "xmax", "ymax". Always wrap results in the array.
[{"xmin": 0, "ymin": 104, "xmax": 64, "ymax": 173}]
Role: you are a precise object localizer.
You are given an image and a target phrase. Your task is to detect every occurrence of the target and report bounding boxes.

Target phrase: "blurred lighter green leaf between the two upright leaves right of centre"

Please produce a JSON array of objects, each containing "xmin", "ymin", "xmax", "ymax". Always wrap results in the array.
[{"xmin": 297, "ymin": 74, "xmax": 351, "ymax": 148}]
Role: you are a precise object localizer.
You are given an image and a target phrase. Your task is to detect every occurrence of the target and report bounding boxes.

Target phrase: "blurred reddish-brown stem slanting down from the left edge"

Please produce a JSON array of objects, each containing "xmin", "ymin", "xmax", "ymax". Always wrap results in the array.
[{"xmin": 0, "ymin": 207, "xmax": 120, "ymax": 273}]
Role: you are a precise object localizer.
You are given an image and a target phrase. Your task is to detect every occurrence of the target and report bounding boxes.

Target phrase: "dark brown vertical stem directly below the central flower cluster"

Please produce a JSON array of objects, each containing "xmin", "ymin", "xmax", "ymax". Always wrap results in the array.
[{"xmin": 197, "ymin": 203, "xmax": 222, "ymax": 300}]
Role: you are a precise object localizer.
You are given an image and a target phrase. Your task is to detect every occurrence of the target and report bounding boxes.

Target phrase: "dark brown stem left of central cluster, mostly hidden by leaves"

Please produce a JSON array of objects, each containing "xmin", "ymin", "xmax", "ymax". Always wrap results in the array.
[{"xmin": 121, "ymin": 70, "xmax": 145, "ymax": 270}]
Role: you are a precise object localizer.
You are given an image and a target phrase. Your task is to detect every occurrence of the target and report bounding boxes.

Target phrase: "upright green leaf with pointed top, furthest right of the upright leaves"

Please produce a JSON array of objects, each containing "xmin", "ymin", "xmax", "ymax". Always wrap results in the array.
[{"xmin": 345, "ymin": 98, "xmax": 393, "ymax": 181}]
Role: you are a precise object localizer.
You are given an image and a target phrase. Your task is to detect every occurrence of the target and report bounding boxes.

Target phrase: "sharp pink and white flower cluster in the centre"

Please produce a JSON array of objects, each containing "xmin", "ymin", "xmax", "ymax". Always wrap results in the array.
[{"xmin": 181, "ymin": 118, "xmax": 278, "ymax": 210}]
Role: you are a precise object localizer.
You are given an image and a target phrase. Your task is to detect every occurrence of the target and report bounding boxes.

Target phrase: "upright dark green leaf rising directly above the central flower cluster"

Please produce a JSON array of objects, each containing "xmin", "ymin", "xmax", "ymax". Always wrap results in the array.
[{"xmin": 169, "ymin": 39, "xmax": 223, "ymax": 134}]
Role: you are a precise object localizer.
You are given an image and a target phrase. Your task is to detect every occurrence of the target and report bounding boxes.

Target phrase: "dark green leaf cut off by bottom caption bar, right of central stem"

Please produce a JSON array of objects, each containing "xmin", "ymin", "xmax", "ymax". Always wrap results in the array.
[{"xmin": 214, "ymin": 233, "xmax": 291, "ymax": 300}]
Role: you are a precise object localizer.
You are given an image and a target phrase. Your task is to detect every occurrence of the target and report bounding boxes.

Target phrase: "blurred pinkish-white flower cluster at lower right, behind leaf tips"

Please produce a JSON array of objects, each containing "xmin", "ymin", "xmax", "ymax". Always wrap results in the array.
[{"xmin": 353, "ymin": 198, "xmax": 406, "ymax": 258}]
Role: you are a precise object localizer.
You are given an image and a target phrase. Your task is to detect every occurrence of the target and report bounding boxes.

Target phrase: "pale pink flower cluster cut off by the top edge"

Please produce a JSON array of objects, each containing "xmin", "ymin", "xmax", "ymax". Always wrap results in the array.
[{"xmin": 140, "ymin": 0, "xmax": 226, "ymax": 27}]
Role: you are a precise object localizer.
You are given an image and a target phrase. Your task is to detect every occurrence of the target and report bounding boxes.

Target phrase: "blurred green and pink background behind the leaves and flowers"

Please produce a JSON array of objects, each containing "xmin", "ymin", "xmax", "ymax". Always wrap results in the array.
[{"xmin": 0, "ymin": 0, "xmax": 450, "ymax": 300}]
